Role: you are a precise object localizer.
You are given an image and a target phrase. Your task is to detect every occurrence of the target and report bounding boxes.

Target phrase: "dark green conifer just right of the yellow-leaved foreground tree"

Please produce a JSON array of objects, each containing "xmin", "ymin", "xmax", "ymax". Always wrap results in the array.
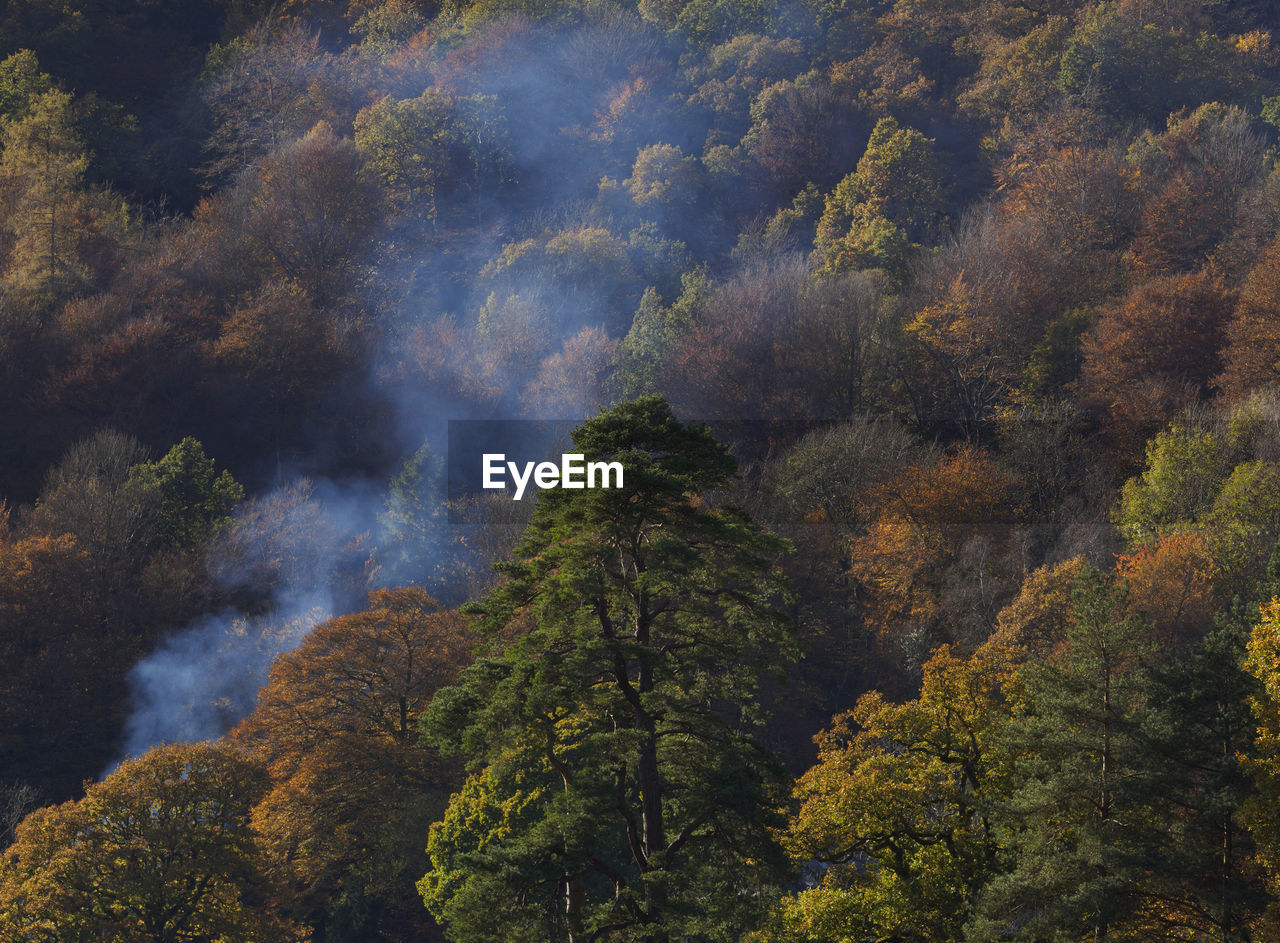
[{"xmin": 966, "ymin": 571, "xmax": 1158, "ymax": 943}]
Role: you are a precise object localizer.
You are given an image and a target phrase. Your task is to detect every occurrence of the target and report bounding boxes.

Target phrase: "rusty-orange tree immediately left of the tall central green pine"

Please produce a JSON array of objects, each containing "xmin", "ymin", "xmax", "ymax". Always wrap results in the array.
[{"xmin": 232, "ymin": 587, "xmax": 475, "ymax": 939}]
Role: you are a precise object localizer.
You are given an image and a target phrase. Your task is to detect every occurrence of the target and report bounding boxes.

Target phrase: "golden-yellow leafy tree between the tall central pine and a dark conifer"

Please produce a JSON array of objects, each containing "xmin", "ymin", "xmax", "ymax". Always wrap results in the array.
[{"xmin": 764, "ymin": 645, "xmax": 1019, "ymax": 943}]
